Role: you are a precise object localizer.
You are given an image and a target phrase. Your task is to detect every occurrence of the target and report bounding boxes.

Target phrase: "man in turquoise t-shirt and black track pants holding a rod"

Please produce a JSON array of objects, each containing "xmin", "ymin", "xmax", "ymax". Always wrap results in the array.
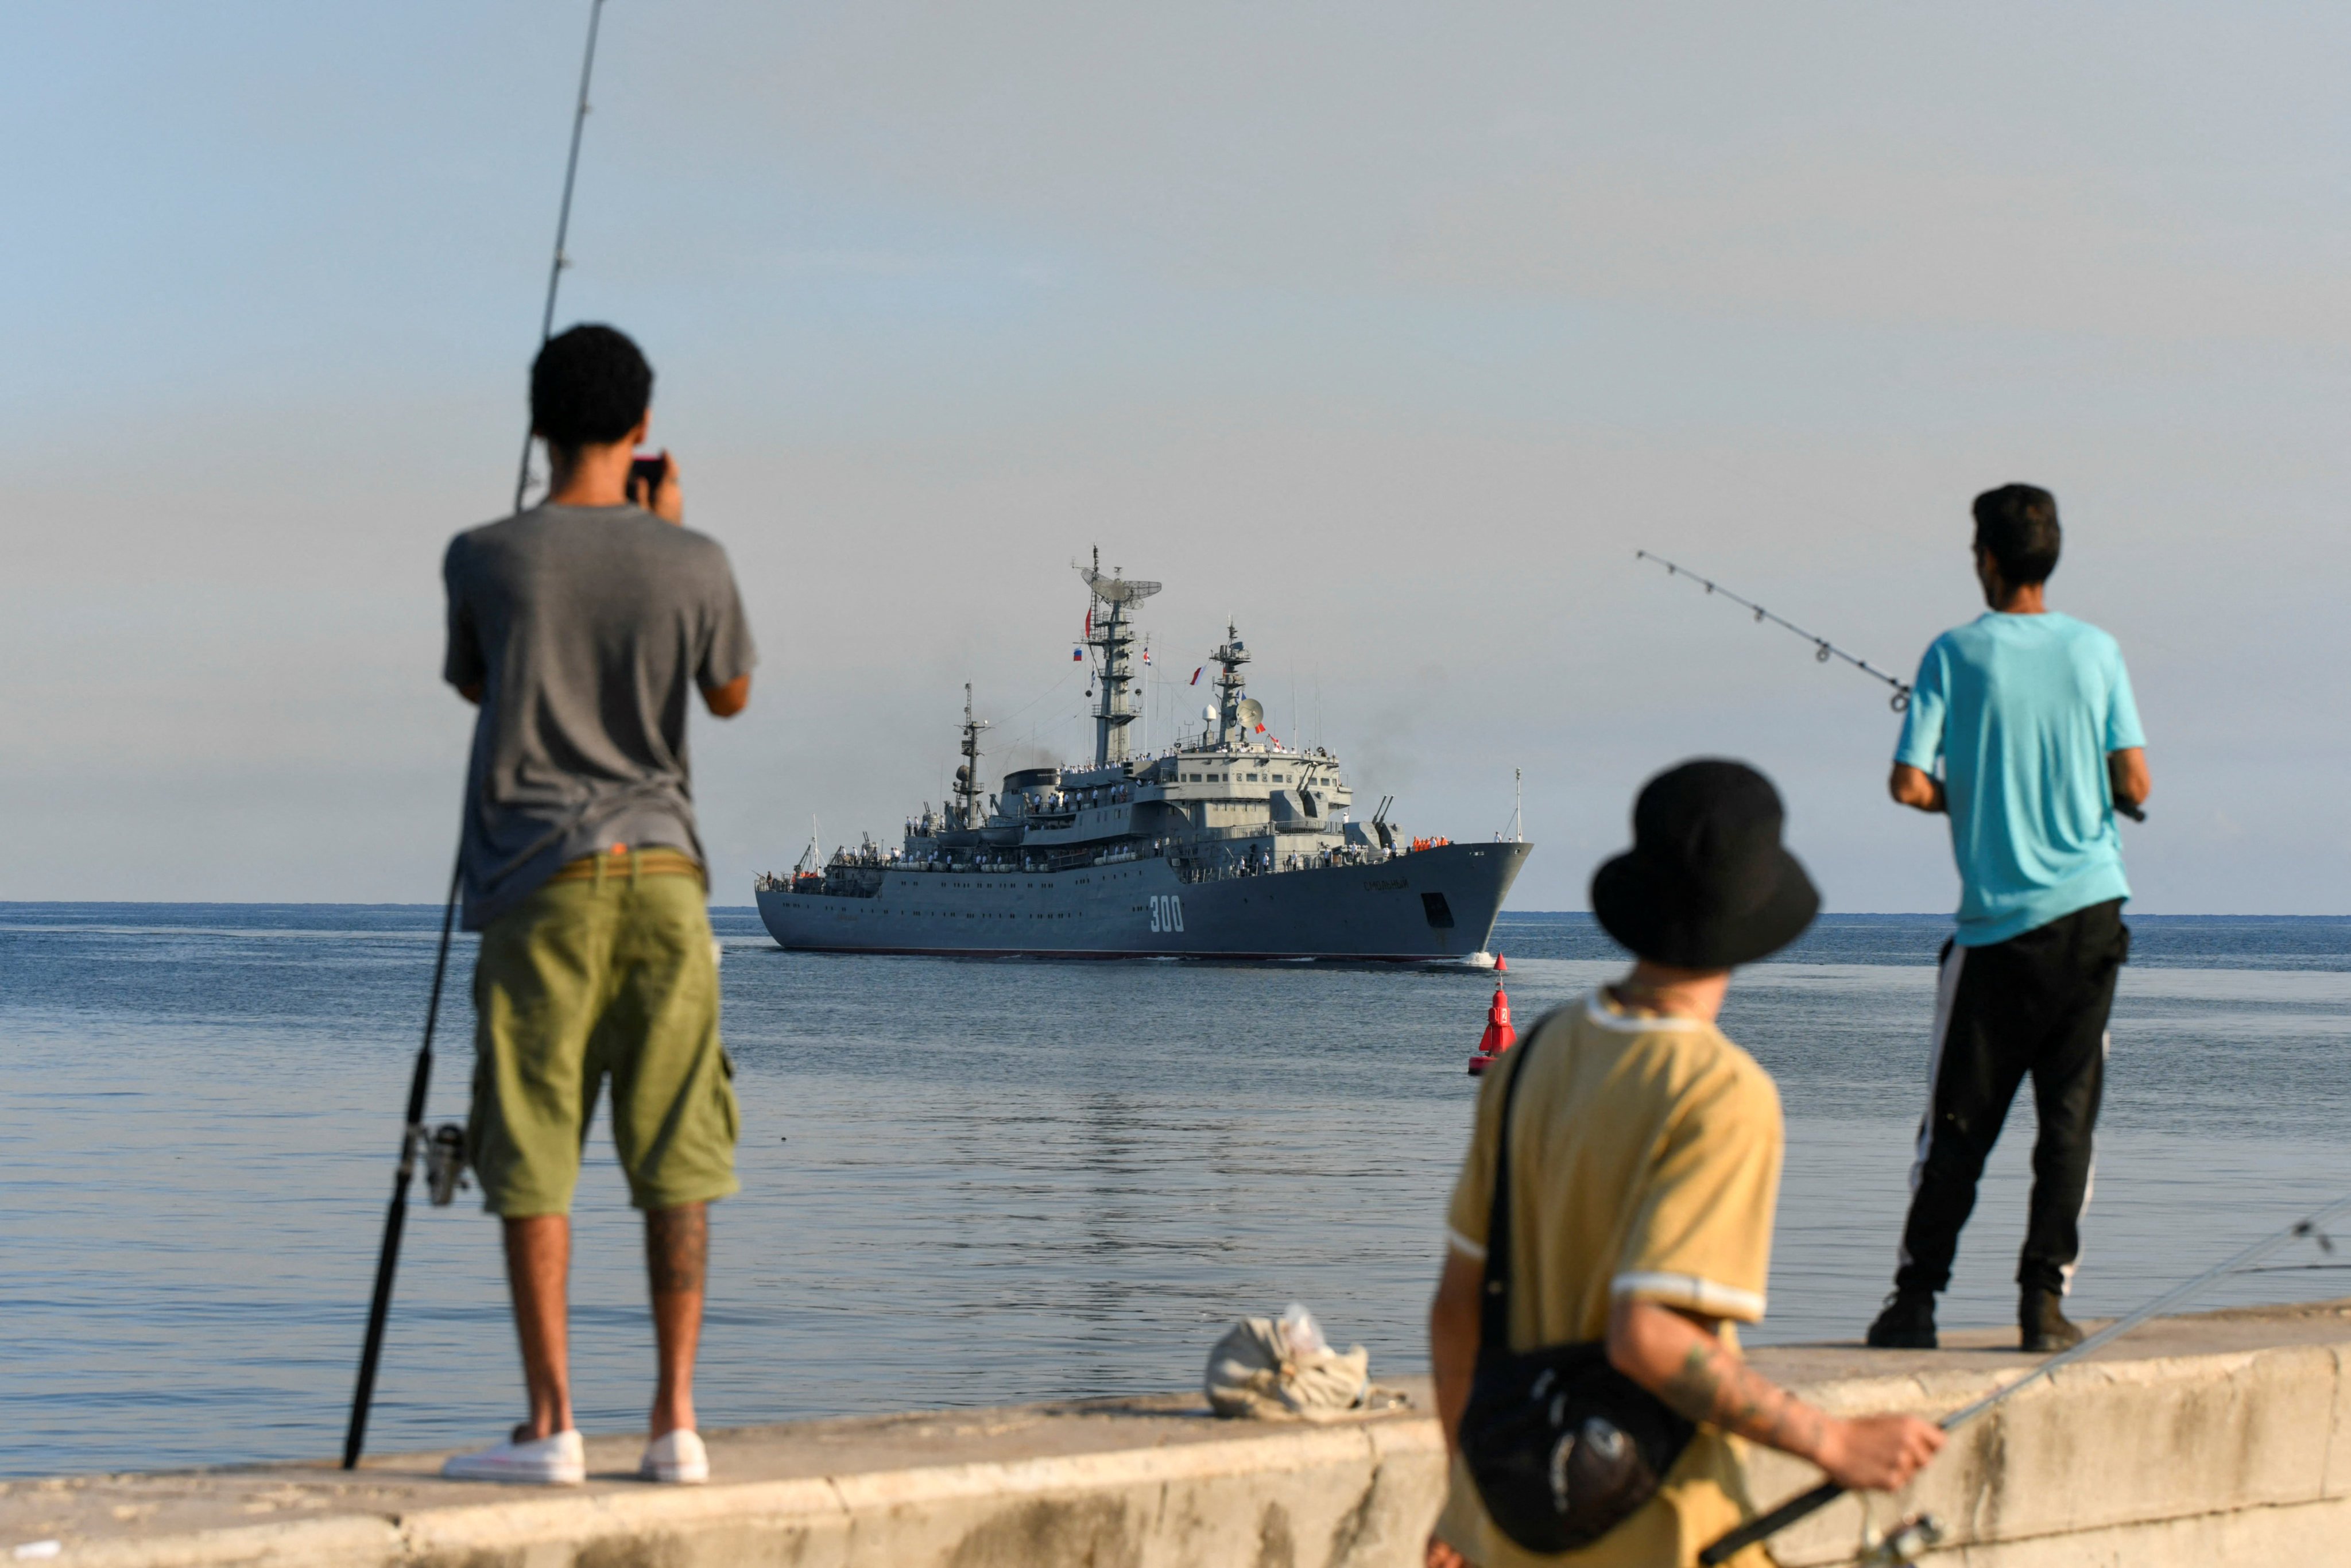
[{"xmin": 1869, "ymin": 484, "xmax": 2149, "ymax": 1349}]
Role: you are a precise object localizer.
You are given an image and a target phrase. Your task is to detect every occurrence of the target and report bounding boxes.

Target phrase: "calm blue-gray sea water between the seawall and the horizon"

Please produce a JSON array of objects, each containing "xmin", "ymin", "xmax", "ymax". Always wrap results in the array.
[{"xmin": 0, "ymin": 905, "xmax": 2351, "ymax": 1474}]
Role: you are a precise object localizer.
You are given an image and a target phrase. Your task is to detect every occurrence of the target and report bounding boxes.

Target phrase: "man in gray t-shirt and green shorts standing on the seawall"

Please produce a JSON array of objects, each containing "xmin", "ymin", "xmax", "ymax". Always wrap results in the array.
[{"xmin": 442, "ymin": 327, "xmax": 754, "ymax": 1484}]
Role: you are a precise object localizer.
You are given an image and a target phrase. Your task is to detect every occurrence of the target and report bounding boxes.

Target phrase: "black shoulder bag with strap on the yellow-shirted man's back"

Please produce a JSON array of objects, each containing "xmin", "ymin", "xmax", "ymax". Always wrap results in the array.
[{"xmin": 1460, "ymin": 1032, "xmax": 1698, "ymax": 1551}]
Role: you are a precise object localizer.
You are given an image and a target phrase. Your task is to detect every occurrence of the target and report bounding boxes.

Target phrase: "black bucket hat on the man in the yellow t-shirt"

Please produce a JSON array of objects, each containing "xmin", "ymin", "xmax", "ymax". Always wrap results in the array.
[{"xmin": 1591, "ymin": 757, "xmax": 1820, "ymax": 969}]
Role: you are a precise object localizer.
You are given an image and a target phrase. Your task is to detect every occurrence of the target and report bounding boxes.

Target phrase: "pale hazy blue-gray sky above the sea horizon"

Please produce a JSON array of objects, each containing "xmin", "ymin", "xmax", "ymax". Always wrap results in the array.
[{"xmin": 0, "ymin": 0, "xmax": 2351, "ymax": 912}]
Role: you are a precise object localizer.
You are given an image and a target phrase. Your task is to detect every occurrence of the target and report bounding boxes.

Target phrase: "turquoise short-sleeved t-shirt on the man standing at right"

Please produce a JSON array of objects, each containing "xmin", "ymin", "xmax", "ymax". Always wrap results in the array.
[{"xmin": 1895, "ymin": 611, "xmax": 2147, "ymax": 947}]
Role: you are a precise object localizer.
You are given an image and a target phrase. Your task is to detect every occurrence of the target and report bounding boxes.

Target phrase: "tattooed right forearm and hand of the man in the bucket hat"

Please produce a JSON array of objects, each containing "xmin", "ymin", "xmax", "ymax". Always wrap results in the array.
[{"xmin": 1608, "ymin": 1295, "xmax": 1942, "ymax": 1493}]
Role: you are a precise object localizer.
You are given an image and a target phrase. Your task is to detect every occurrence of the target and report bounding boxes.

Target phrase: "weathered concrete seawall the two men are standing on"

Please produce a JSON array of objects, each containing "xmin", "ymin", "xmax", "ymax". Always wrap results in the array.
[{"xmin": 0, "ymin": 1302, "xmax": 2351, "ymax": 1568}]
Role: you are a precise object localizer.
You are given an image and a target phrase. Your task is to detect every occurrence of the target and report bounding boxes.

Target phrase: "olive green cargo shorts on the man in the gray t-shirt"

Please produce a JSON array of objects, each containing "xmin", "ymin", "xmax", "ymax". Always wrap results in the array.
[{"xmin": 466, "ymin": 855, "xmax": 741, "ymax": 1218}]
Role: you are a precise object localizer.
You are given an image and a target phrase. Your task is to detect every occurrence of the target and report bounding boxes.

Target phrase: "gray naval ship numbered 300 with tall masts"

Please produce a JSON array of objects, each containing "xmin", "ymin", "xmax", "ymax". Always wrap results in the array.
[{"xmin": 757, "ymin": 552, "xmax": 1531, "ymax": 966}]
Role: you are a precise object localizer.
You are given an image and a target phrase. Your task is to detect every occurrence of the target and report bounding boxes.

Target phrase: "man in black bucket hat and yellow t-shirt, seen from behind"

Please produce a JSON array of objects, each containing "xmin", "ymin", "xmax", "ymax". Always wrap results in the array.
[{"xmin": 1427, "ymin": 760, "xmax": 1942, "ymax": 1568}]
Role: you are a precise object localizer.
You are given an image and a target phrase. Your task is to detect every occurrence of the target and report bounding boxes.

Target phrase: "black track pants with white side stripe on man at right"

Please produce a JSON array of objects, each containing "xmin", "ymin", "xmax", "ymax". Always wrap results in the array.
[{"xmin": 1895, "ymin": 898, "xmax": 2130, "ymax": 1293}]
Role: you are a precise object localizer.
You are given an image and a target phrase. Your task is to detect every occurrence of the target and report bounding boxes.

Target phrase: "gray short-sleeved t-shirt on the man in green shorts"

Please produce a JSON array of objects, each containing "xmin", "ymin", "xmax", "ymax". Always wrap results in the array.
[{"xmin": 442, "ymin": 505, "xmax": 757, "ymax": 931}]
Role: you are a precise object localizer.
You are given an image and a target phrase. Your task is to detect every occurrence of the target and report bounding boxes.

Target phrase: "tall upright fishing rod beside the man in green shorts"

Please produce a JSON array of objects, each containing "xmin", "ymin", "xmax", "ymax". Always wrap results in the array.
[{"xmin": 343, "ymin": 0, "xmax": 604, "ymax": 1469}]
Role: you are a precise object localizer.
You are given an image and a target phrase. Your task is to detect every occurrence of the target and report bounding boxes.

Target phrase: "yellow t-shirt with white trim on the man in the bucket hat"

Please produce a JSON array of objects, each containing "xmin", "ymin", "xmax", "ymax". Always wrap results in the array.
[{"xmin": 1439, "ymin": 992, "xmax": 1782, "ymax": 1568}]
